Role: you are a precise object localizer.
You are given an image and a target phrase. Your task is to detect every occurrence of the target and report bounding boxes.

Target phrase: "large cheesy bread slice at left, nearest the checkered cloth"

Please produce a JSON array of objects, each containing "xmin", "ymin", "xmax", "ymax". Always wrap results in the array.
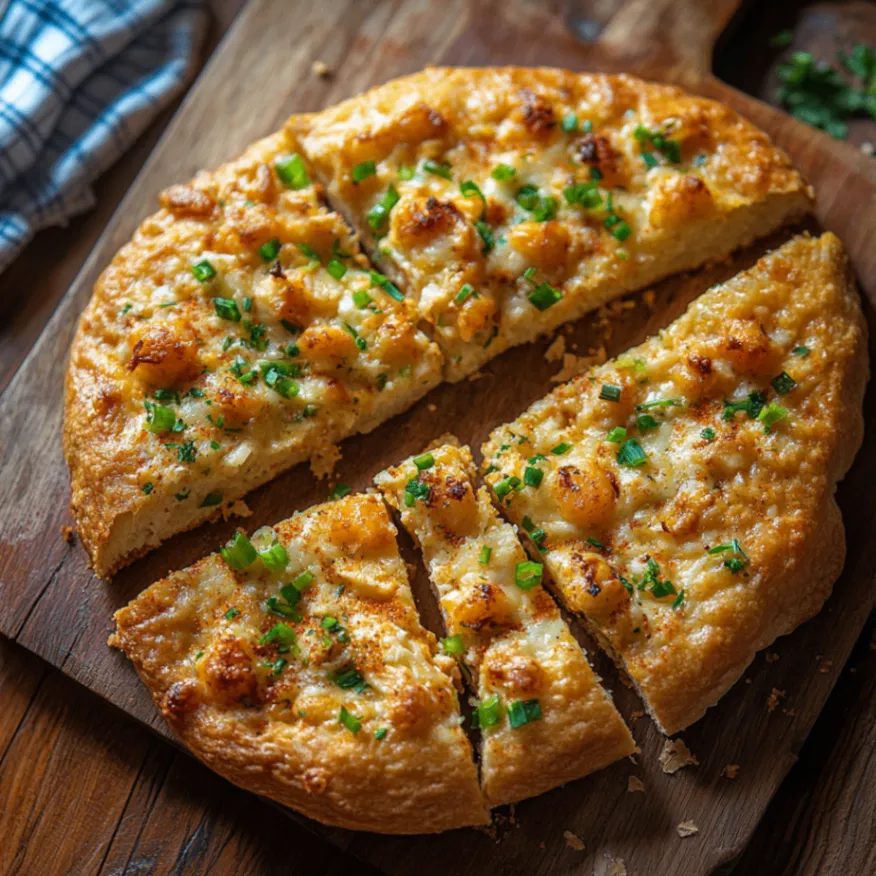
[{"xmin": 65, "ymin": 134, "xmax": 441, "ymax": 575}]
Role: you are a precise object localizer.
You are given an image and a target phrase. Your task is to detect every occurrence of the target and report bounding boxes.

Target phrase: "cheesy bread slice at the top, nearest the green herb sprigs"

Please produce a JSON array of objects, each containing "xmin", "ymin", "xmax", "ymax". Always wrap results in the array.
[{"xmin": 289, "ymin": 68, "xmax": 811, "ymax": 380}]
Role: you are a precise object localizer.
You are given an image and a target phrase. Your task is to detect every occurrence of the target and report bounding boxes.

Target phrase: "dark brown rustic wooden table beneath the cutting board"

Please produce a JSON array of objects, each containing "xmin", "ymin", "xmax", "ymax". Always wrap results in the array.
[{"xmin": 0, "ymin": 0, "xmax": 876, "ymax": 876}]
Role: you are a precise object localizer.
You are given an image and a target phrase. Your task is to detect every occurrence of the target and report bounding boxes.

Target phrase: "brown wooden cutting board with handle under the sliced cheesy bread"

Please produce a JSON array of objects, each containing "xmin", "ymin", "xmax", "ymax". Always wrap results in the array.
[{"xmin": 0, "ymin": 0, "xmax": 876, "ymax": 876}]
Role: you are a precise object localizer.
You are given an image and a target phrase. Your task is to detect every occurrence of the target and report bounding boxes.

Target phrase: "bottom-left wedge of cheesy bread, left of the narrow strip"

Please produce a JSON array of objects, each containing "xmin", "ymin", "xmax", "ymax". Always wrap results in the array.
[{"xmin": 110, "ymin": 495, "xmax": 488, "ymax": 833}]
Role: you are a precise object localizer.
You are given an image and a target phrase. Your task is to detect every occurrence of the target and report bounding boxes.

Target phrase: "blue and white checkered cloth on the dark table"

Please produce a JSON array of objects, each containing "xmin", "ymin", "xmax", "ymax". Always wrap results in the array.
[{"xmin": 0, "ymin": 0, "xmax": 206, "ymax": 271}]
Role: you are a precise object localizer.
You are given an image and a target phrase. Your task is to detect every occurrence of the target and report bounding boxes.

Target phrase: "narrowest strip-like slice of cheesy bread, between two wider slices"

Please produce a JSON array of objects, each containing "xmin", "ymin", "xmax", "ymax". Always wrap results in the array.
[{"xmin": 375, "ymin": 439, "xmax": 636, "ymax": 806}]
